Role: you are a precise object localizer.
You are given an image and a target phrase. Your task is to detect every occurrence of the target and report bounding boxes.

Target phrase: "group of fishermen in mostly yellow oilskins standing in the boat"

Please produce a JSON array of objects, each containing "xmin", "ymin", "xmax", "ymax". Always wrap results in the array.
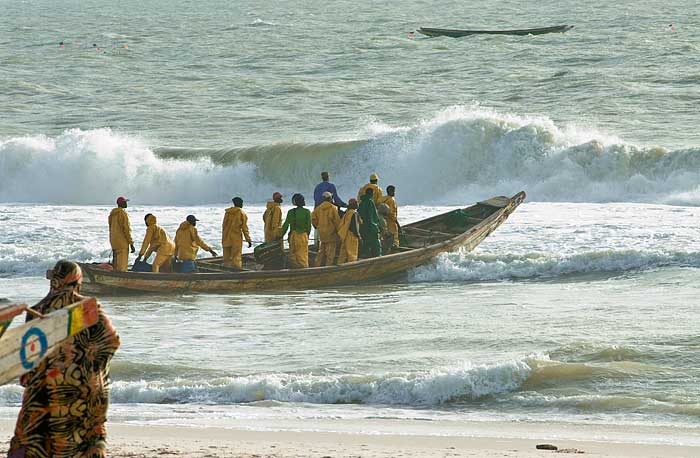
[{"xmin": 108, "ymin": 172, "xmax": 400, "ymax": 272}]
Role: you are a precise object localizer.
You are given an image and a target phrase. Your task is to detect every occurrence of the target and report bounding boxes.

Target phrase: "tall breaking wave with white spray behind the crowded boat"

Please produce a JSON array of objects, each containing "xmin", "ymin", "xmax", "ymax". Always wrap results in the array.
[{"xmin": 0, "ymin": 105, "xmax": 700, "ymax": 205}]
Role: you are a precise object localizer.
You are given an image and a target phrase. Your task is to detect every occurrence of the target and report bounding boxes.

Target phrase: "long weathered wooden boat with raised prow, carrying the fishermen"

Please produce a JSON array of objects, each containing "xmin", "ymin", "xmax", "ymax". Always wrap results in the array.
[{"xmin": 80, "ymin": 192, "xmax": 525, "ymax": 294}]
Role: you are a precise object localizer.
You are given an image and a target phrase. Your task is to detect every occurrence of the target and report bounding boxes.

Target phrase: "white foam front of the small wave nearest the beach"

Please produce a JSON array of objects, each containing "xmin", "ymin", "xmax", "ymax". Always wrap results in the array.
[{"xmin": 104, "ymin": 360, "xmax": 531, "ymax": 406}]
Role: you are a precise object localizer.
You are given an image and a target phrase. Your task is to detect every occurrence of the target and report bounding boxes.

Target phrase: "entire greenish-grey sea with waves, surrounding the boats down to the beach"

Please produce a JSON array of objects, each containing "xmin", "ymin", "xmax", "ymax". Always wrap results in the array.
[{"xmin": 0, "ymin": 0, "xmax": 700, "ymax": 443}]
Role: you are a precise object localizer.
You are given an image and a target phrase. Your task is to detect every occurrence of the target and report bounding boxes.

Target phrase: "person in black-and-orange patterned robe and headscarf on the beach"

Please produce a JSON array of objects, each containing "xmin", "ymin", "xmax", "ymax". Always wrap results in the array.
[{"xmin": 8, "ymin": 261, "xmax": 120, "ymax": 458}]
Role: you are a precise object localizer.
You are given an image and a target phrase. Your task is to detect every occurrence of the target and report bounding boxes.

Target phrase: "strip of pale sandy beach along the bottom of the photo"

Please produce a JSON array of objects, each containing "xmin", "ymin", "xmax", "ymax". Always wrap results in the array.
[{"xmin": 0, "ymin": 421, "xmax": 700, "ymax": 458}]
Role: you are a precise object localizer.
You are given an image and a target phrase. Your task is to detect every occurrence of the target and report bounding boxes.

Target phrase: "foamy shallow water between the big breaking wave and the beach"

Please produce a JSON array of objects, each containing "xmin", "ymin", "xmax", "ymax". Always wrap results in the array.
[{"xmin": 0, "ymin": 203, "xmax": 700, "ymax": 440}]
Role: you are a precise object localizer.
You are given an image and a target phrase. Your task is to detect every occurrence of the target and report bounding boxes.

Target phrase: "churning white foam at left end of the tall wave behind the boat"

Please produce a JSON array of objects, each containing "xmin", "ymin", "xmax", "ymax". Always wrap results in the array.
[{"xmin": 0, "ymin": 129, "xmax": 266, "ymax": 204}]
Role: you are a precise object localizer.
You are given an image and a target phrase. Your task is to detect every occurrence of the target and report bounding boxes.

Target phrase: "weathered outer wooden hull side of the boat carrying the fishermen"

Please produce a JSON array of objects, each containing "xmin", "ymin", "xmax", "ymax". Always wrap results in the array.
[{"xmin": 81, "ymin": 192, "xmax": 525, "ymax": 293}]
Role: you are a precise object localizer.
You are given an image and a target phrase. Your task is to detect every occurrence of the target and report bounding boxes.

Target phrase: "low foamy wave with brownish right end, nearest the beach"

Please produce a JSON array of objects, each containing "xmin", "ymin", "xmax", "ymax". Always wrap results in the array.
[{"xmin": 0, "ymin": 345, "xmax": 700, "ymax": 417}]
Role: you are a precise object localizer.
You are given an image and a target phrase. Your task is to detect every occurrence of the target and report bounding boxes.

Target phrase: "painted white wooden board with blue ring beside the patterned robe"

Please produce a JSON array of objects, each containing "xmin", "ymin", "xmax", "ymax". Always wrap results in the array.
[{"xmin": 0, "ymin": 297, "xmax": 99, "ymax": 385}]
